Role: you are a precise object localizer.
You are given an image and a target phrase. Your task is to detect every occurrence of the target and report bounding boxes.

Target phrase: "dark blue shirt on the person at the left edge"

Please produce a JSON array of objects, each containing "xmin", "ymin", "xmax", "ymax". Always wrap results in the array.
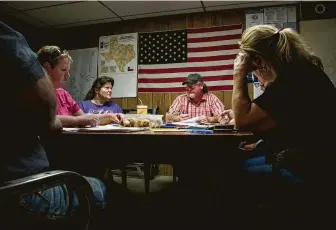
[{"xmin": 0, "ymin": 22, "xmax": 49, "ymax": 182}]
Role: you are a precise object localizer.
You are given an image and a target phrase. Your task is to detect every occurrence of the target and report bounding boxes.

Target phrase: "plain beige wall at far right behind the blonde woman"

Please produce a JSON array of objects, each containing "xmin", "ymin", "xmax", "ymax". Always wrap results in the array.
[{"xmin": 300, "ymin": 19, "xmax": 336, "ymax": 85}]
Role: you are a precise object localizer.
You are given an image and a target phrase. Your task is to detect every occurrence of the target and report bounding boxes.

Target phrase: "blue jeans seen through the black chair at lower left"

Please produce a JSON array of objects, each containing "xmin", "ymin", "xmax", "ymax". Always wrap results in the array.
[{"xmin": 20, "ymin": 177, "xmax": 107, "ymax": 217}]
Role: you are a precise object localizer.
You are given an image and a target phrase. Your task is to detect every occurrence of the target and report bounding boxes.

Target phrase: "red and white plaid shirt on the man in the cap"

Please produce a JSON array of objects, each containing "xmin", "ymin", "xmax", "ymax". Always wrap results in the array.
[{"xmin": 168, "ymin": 93, "xmax": 225, "ymax": 121}]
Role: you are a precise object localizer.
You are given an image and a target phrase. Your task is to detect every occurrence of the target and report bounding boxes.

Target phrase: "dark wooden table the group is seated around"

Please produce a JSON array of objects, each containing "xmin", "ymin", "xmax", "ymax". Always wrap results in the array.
[{"xmin": 45, "ymin": 131, "xmax": 253, "ymax": 192}]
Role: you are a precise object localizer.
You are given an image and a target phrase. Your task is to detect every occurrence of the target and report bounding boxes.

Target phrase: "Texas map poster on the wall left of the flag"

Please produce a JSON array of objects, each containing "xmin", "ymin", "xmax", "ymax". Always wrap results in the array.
[{"xmin": 98, "ymin": 33, "xmax": 138, "ymax": 98}]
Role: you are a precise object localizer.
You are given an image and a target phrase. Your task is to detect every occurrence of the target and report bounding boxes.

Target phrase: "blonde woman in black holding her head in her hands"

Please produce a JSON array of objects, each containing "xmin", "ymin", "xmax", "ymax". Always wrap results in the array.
[{"xmin": 232, "ymin": 25, "xmax": 336, "ymax": 226}]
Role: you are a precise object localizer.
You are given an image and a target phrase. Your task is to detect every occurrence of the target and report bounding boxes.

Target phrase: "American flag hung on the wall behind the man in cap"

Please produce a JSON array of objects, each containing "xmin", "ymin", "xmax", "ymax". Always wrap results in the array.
[{"xmin": 138, "ymin": 24, "xmax": 242, "ymax": 93}]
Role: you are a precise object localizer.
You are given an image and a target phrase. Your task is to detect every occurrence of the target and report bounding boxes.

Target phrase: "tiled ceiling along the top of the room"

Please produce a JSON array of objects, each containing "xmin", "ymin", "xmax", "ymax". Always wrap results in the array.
[{"xmin": 0, "ymin": 0, "xmax": 300, "ymax": 28}]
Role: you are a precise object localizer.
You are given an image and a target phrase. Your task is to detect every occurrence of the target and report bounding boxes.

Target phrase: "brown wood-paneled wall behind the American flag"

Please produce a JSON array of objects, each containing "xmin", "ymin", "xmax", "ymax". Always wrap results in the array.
[{"xmin": 54, "ymin": 9, "xmax": 253, "ymax": 114}]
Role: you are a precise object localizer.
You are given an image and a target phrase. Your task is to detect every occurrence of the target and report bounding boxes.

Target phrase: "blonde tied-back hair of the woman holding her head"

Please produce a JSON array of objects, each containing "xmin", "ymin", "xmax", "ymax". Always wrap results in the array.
[{"xmin": 240, "ymin": 25, "xmax": 323, "ymax": 69}]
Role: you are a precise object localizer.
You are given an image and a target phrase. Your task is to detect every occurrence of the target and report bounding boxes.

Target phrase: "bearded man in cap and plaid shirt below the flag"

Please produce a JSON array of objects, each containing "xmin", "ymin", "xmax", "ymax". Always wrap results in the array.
[{"xmin": 166, "ymin": 73, "xmax": 234, "ymax": 125}]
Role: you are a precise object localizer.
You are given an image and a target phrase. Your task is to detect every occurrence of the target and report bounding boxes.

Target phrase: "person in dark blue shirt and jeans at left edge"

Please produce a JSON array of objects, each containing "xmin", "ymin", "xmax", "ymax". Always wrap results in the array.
[{"xmin": 0, "ymin": 21, "xmax": 107, "ymax": 216}]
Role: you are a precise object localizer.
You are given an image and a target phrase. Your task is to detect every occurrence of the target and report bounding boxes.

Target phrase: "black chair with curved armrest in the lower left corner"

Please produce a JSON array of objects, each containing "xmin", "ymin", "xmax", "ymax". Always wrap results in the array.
[{"xmin": 0, "ymin": 170, "xmax": 98, "ymax": 230}]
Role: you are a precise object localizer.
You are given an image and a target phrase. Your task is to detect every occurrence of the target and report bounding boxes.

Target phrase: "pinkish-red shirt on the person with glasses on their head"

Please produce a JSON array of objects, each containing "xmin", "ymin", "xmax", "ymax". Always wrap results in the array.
[{"xmin": 56, "ymin": 88, "xmax": 80, "ymax": 116}]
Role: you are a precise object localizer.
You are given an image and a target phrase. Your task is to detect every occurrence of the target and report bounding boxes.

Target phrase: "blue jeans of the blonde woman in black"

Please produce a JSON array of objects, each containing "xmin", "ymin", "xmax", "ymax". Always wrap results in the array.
[{"xmin": 244, "ymin": 156, "xmax": 303, "ymax": 184}]
